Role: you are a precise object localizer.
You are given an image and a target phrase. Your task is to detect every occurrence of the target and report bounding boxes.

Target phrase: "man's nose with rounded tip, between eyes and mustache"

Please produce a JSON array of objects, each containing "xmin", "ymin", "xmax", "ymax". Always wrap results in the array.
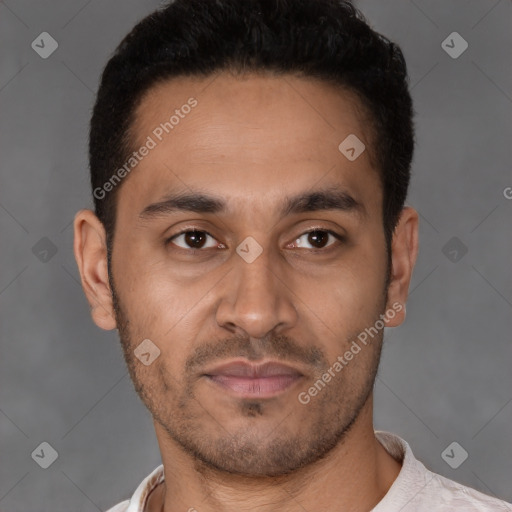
[{"xmin": 216, "ymin": 250, "xmax": 297, "ymax": 338}]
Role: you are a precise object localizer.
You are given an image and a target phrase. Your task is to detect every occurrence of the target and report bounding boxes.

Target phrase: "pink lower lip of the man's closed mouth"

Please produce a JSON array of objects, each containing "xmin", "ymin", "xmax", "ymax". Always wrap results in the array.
[{"xmin": 207, "ymin": 375, "xmax": 301, "ymax": 398}]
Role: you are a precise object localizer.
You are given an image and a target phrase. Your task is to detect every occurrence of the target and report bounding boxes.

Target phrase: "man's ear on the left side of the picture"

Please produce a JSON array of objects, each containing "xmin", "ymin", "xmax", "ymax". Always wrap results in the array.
[{"xmin": 73, "ymin": 210, "xmax": 116, "ymax": 330}]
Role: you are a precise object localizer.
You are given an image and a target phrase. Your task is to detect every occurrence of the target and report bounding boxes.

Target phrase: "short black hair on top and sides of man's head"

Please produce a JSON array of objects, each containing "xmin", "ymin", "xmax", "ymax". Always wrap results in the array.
[{"xmin": 89, "ymin": 0, "xmax": 414, "ymax": 256}]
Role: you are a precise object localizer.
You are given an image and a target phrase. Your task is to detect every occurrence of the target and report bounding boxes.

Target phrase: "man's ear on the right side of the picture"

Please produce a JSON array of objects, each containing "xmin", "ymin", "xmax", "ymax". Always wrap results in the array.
[{"xmin": 386, "ymin": 206, "xmax": 418, "ymax": 327}]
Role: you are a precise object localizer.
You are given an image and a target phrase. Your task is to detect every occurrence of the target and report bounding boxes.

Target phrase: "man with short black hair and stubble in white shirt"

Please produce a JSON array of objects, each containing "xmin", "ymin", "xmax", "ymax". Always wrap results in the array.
[{"xmin": 74, "ymin": 0, "xmax": 509, "ymax": 512}]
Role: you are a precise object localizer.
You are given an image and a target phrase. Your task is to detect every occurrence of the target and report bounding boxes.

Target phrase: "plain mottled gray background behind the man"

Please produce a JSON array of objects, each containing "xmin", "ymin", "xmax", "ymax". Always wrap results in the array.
[{"xmin": 0, "ymin": 0, "xmax": 512, "ymax": 512}]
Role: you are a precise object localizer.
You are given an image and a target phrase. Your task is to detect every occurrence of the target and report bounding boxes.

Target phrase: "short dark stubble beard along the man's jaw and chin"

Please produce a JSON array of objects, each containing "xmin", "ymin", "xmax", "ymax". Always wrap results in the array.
[{"xmin": 110, "ymin": 272, "xmax": 385, "ymax": 477}]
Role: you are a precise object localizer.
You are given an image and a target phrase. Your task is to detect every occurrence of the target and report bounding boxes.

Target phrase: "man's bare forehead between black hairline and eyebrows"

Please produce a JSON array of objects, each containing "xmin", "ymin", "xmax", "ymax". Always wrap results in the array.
[{"xmin": 120, "ymin": 72, "xmax": 378, "ymax": 218}]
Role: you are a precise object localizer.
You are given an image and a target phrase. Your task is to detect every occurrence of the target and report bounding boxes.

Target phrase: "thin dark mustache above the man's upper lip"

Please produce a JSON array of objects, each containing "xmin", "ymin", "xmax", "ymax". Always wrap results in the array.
[{"xmin": 185, "ymin": 335, "xmax": 329, "ymax": 373}]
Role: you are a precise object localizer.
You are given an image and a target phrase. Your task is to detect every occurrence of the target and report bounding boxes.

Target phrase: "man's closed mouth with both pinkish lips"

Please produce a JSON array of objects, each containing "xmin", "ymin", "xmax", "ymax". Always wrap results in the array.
[{"xmin": 204, "ymin": 360, "xmax": 304, "ymax": 398}]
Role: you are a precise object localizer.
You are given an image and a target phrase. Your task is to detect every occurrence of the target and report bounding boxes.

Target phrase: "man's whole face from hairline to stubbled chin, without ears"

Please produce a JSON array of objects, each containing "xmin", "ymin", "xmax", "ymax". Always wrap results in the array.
[{"xmin": 77, "ymin": 73, "xmax": 416, "ymax": 476}]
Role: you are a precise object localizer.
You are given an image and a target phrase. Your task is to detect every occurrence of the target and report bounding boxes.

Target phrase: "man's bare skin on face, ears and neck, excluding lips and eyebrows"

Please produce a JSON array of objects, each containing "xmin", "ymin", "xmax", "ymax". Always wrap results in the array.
[{"xmin": 74, "ymin": 72, "xmax": 418, "ymax": 512}]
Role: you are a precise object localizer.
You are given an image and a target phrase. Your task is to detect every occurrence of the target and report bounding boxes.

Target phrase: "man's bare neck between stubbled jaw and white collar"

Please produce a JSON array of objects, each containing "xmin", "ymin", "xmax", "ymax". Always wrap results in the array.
[{"xmin": 148, "ymin": 398, "xmax": 400, "ymax": 512}]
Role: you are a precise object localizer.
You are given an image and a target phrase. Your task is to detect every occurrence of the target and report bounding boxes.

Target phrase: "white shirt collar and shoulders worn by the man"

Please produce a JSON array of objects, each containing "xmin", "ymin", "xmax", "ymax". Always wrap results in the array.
[{"xmin": 107, "ymin": 432, "xmax": 512, "ymax": 512}]
